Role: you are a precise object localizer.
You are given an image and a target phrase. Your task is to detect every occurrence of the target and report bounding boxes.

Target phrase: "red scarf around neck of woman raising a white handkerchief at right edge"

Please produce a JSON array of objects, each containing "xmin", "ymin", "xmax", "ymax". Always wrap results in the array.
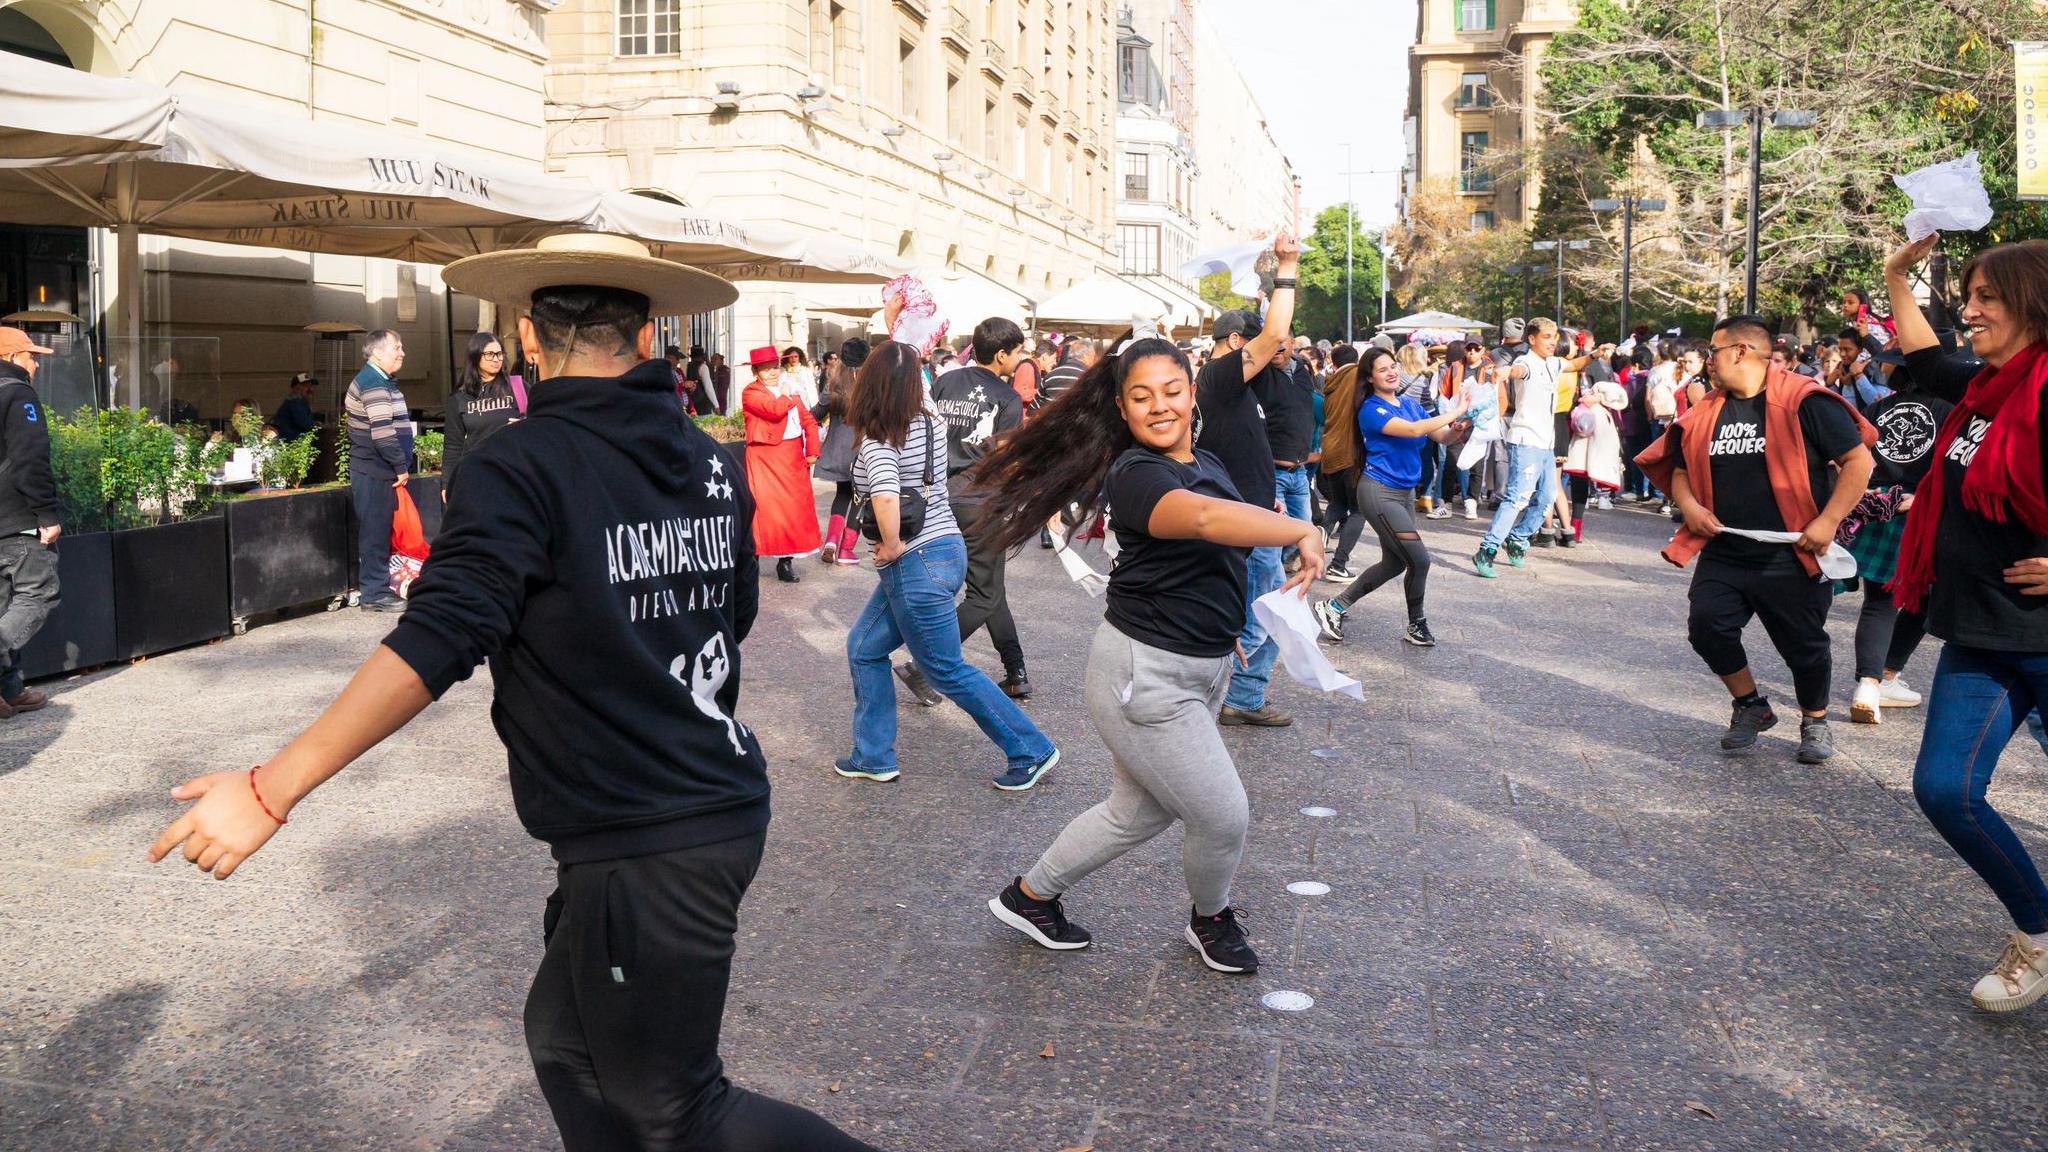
[{"xmin": 1890, "ymin": 344, "xmax": 2048, "ymax": 611}]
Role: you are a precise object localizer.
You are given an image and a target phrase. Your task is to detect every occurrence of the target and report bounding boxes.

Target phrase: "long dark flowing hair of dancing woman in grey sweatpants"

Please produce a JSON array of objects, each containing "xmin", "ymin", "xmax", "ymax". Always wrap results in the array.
[{"xmin": 973, "ymin": 332, "xmax": 1194, "ymax": 549}]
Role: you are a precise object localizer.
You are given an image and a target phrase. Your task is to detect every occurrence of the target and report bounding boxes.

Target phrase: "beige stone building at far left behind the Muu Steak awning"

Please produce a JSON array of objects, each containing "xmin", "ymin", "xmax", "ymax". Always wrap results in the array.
[{"xmin": 0, "ymin": 0, "xmax": 549, "ymax": 418}]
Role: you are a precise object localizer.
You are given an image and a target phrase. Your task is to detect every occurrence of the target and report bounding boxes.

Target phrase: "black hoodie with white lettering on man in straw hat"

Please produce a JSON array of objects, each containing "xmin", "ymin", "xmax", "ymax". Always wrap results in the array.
[{"xmin": 385, "ymin": 361, "xmax": 768, "ymax": 863}]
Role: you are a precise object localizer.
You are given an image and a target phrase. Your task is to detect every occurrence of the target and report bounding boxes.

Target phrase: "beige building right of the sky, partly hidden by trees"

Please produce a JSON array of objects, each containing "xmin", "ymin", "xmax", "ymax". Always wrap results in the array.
[{"xmin": 1407, "ymin": 0, "xmax": 1577, "ymax": 230}]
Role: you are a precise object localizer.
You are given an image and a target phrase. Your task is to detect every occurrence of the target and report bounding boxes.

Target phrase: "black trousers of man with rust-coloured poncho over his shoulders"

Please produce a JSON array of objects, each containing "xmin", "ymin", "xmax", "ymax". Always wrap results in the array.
[{"xmin": 1686, "ymin": 549, "xmax": 1835, "ymax": 711}]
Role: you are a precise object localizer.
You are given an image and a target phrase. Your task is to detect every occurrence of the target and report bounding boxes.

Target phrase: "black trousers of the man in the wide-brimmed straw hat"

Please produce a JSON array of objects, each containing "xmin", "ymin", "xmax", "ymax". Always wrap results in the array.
[{"xmin": 526, "ymin": 832, "xmax": 874, "ymax": 1152}]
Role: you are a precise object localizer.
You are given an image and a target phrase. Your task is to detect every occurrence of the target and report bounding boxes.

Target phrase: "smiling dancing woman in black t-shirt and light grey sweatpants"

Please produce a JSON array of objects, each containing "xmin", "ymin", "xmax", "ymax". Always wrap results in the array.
[{"xmin": 977, "ymin": 330, "xmax": 1323, "ymax": 972}]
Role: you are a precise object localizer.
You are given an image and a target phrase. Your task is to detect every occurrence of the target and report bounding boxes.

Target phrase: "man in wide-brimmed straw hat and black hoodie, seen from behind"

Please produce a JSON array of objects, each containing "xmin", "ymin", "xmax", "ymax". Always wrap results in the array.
[{"xmin": 150, "ymin": 236, "xmax": 868, "ymax": 1152}]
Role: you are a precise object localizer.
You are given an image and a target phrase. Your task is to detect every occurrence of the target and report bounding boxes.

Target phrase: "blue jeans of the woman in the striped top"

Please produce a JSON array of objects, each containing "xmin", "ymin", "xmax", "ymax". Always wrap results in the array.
[{"xmin": 846, "ymin": 535, "xmax": 1053, "ymax": 769}]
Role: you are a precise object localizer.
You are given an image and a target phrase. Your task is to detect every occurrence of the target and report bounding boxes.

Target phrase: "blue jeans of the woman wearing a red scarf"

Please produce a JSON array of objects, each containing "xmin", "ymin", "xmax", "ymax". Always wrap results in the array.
[{"xmin": 1913, "ymin": 644, "xmax": 2048, "ymax": 933}]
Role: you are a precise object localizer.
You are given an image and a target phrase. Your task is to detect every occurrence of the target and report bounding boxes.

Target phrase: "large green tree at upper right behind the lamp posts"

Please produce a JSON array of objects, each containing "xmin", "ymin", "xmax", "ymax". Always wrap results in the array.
[{"xmin": 1522, "ymin": 0, "xmax": 2048, "ymax": 316}]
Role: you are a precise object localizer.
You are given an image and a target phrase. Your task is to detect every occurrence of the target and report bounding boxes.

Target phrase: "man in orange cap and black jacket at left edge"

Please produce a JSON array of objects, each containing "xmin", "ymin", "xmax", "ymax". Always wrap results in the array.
[{"xmin": 0, "ymin": 328, "xmax": 63, "ymax": 719}]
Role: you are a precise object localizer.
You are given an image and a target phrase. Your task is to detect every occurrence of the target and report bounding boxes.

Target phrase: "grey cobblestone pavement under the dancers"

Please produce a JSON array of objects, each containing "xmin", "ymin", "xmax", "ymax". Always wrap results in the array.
[{"xmin": 0, "ymin": 494, "xmax": 2048, "ymax": 1152}]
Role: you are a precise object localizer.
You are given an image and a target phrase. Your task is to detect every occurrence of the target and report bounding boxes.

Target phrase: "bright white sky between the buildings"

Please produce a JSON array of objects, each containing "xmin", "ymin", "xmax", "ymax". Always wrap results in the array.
[{"xmin": 1196, "ymin": 0, "xmax": 1415, "ymax": 228}]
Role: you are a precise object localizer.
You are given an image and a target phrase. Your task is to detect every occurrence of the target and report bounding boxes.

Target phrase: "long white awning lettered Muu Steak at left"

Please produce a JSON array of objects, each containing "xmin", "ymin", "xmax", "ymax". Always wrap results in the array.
[{"xmin": 0, "ymin": 57, "xmax": 891, "ymax": 354}]
